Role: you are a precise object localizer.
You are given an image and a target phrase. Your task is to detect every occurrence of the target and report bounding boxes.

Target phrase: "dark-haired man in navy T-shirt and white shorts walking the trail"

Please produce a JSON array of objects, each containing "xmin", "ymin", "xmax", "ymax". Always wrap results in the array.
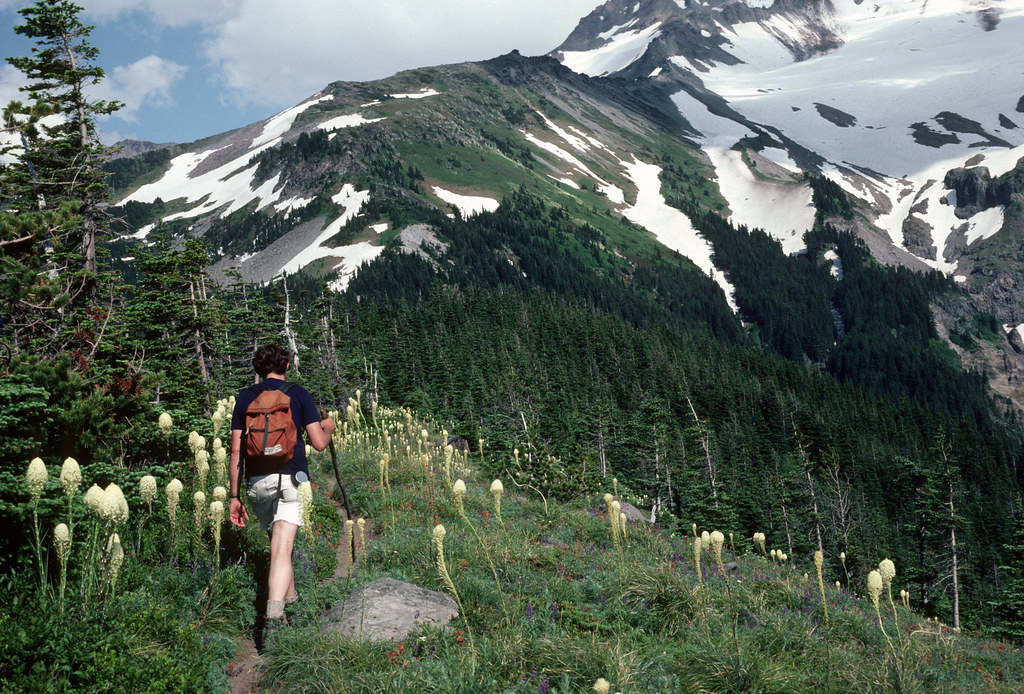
[{"xmin": 228, "ymin": 344, "xmax": 335, "ymax": 630}]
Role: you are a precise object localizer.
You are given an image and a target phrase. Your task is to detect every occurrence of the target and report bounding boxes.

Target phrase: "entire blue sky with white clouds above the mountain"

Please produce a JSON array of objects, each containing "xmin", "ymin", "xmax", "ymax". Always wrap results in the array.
[{"xmin": 0, "ymin": 0, "xmax": 601, "ymax": 143}]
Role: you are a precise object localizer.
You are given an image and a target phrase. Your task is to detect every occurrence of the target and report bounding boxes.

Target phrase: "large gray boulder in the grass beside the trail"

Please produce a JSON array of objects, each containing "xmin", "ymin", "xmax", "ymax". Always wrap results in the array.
[{"xmin": 324, "ymin": 578, "xmax": 459, "ymax": 641}]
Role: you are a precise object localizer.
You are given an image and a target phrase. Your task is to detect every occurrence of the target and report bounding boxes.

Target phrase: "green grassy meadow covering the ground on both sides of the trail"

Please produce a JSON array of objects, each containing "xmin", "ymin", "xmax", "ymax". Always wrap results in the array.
[{"xmin": 12, "ymin": 405, "xmax": 1024, "ymax": 693}]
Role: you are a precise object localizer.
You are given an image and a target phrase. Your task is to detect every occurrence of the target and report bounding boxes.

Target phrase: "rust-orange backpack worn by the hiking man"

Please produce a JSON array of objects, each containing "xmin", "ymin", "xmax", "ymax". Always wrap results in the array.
[{"xmin": 245, "ymin": 383, "xmax": 299, "ymax": 477}]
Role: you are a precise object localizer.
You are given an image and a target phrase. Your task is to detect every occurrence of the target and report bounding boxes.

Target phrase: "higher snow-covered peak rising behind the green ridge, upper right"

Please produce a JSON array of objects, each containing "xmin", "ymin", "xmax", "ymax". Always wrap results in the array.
[{"xmin": 556, "ymin": 0, "xmax": 1024, "ymax": 275}]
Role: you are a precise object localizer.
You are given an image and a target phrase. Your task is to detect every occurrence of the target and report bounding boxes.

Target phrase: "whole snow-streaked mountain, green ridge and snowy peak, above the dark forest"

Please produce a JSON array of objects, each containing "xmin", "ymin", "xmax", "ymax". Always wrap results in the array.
[{"xmin": 103, "ymin": 0, "xmax": 1024, "ymax": 413}]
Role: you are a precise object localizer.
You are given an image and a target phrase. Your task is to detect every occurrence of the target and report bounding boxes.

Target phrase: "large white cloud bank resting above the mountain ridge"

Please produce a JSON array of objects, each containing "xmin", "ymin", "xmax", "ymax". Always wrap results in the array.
[{"xmin": 200, "ymin": 0, "xmax": 595, "ymax": 102}]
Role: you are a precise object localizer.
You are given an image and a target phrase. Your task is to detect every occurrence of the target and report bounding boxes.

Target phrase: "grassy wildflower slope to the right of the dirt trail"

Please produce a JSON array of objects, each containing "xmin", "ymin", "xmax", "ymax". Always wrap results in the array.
[{"xmin": 258, "ymin": 405, "xmax": 1024, "ymax": 692}]
